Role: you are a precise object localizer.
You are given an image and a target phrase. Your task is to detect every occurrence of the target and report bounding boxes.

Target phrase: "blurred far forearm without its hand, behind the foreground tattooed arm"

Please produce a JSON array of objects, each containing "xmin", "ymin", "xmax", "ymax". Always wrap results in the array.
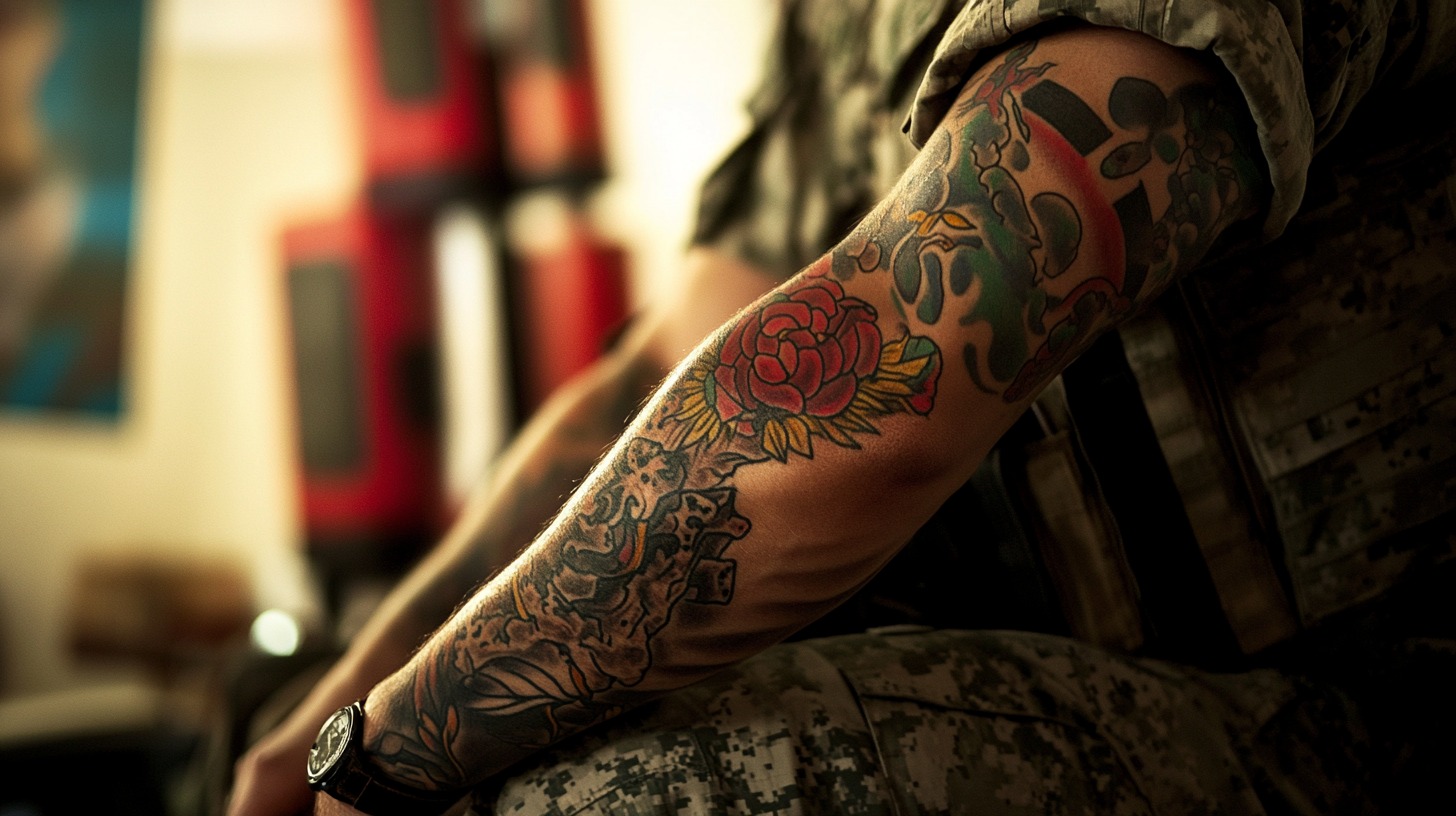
[{"xmin": 314, "ymin": 249, "xmax": 769, "ymax": 702}]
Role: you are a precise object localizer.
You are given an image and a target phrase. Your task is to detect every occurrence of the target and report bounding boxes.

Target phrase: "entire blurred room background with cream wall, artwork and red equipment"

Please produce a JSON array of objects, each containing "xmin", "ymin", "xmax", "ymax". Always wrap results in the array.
[{"xmin": 0, "ymin": 0, "xmax": 773, "ymax": 816}]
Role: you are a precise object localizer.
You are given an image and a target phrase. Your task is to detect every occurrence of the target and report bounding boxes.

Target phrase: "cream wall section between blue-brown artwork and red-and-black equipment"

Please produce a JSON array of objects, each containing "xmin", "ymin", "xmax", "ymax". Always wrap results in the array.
[{"xmin": 0, "ymin": 0, "xmax": 357, "ymax": 692}]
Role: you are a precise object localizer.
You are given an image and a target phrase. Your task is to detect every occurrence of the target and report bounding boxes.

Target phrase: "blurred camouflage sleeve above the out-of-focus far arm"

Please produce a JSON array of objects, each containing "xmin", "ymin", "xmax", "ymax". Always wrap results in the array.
[{"xmin": 692, "ymin": 0, "xmax": 972, "ymax": 280}]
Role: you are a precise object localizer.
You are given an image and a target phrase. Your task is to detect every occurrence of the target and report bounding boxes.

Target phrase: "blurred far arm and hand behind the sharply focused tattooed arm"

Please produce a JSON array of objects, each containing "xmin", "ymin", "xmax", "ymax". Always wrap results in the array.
[{"xmin": 229, "ymin": 249, "xmax": 772, "ymax": 816}]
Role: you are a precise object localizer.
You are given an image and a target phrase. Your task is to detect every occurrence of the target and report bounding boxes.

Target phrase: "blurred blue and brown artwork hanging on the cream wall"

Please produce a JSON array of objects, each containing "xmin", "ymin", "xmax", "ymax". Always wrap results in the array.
[{"xmin": 0, "ymin": 0, "xmax": 146, "ymax": 420}]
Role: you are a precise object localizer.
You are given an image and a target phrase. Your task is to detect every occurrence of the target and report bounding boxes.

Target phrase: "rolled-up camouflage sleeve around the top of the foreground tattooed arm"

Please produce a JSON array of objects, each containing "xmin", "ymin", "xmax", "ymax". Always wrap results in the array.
[{"xmin": 904, "ymin": 0, "xmax": 1396, "ymax": 238}]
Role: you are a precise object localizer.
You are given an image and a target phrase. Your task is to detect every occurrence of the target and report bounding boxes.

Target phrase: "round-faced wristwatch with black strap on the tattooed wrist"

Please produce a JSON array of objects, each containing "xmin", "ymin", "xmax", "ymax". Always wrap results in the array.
[{"xmin": 309, "ymin": 701, "xmax": 463, "ymax": 816}]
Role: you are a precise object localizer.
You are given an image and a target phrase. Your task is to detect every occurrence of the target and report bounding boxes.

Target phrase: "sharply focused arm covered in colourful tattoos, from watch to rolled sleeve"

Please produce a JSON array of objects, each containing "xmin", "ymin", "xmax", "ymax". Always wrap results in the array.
[{"xmin": 324, "ymin": 29, "xmax": 1262, "ymax": 810}]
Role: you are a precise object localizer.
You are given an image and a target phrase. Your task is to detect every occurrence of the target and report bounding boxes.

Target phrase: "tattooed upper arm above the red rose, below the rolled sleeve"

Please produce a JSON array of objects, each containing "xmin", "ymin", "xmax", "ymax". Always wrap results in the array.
[{"xmin": 827, "ymin": 28, "xmax": 1267, "ymax": 404}]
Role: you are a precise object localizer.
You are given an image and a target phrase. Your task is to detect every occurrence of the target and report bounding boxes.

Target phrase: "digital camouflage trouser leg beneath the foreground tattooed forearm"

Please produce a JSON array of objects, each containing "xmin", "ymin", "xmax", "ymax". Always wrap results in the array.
[{"xmin": 475, "ymin": 629, "xmax": 1376, "ymax": 815}]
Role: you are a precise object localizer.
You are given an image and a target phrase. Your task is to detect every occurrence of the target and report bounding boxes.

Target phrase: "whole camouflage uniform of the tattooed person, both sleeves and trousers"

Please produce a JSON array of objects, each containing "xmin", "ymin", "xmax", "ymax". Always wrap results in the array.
[{"xmin": 476, "ymin": 0, "xmax": 1456, "ymax": 813}]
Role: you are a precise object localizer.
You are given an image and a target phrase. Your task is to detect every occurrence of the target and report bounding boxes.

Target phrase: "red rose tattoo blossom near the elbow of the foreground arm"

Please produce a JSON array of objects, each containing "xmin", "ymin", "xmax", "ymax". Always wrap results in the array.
[{"xmin": 713, "ymin": 278, "xmax": 881, "ymax": 434}]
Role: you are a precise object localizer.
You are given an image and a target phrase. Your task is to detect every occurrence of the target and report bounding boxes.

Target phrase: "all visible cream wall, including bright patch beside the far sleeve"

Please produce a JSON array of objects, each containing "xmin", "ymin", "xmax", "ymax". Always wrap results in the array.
[{"xmin": 0, "ymin": 0, "xmax": 770, "ymax": 692}]
